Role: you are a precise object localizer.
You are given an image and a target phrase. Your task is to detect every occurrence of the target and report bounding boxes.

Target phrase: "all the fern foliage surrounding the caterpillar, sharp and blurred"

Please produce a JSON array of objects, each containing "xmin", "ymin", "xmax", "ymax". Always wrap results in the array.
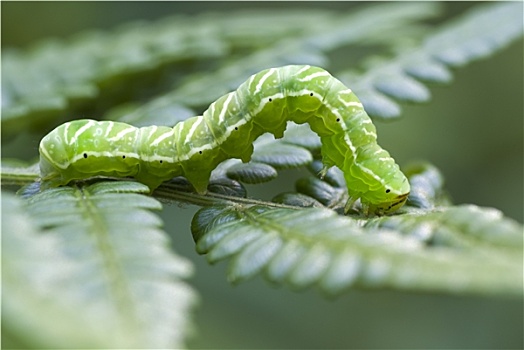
[{"xmin": 1, "ymin": 2, "xmax": 523, "ymax": 348}]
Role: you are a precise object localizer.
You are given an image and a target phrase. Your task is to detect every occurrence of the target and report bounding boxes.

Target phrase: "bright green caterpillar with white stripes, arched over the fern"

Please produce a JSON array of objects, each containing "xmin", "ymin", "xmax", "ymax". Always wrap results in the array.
[{"xmin": 40, "ymin": 65, "xmax": 410, "ymax": 214}]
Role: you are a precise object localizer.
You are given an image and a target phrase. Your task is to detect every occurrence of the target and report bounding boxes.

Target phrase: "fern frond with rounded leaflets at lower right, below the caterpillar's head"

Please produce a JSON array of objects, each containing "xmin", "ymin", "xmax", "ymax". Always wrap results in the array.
[{"xmin": 192, "ymin": 206, "xmax": 522, "ymax": 296}]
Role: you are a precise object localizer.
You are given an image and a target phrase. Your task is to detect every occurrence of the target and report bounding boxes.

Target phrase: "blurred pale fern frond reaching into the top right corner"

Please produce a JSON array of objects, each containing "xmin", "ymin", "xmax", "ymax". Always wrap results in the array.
[{"xmin": 337, "ymin": 2, "xmax": 523, "ymax": 119}]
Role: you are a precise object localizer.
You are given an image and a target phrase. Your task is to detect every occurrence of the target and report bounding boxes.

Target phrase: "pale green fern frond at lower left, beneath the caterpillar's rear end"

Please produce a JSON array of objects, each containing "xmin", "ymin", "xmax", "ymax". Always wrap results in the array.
[{"xmin": 2, "ymin": 182, "xmax": 195, "ymax": 348}]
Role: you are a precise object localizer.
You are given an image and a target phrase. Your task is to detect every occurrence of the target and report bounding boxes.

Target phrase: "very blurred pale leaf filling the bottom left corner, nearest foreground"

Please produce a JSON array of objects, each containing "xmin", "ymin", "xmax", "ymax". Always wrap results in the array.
[{"xmin": 2, "ymin": 192, "xmax": 115, "ymax": 348}]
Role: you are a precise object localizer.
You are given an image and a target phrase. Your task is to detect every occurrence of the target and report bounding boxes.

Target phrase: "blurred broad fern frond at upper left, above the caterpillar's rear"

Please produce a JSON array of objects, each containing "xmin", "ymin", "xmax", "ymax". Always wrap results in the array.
[{"xmin": 2, "ymin": 10, "xmax": 340, "ymax": 132}]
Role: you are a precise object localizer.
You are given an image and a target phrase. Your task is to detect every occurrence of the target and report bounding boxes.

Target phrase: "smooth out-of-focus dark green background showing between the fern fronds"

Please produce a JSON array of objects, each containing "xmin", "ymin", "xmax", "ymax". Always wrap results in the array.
[{"xmin": 1, "ymin": 2, "xmax": 524, "ymax": 349}]
